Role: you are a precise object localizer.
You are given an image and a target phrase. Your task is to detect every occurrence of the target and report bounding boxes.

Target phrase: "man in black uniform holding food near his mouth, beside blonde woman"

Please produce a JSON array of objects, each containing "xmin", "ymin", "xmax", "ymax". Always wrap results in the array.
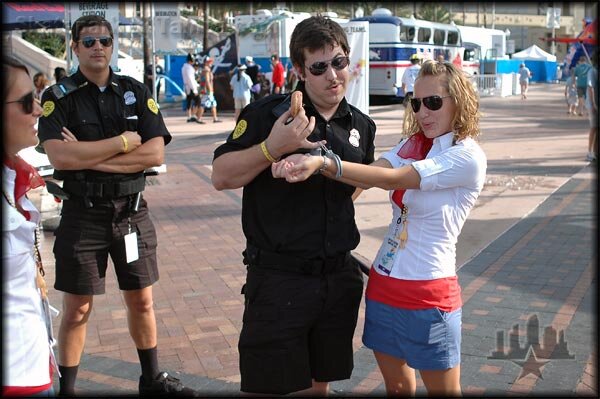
[{"xmin": 212, "ymin": 16, "xmax": 375, "ymax": 397}]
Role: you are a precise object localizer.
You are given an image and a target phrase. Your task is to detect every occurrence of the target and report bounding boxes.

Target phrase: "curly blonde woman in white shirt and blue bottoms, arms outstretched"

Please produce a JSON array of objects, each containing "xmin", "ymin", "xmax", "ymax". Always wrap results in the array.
[{"xmin": 274, "ymin": 61, "xmax": 487, "ymax": 397}]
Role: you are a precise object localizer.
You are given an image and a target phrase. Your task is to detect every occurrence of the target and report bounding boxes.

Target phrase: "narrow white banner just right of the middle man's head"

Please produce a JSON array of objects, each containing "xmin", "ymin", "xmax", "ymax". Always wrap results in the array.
[{"xmin": 340, "ymin": 21, "xmax": 369, "ymax": 115}]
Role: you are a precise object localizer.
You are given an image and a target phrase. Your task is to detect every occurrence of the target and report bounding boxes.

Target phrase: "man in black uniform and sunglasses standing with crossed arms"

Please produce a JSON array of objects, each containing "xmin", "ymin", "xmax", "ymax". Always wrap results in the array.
[{"xmin": 39, "ymin": 15, "xmax": 195, "ymax": 396}]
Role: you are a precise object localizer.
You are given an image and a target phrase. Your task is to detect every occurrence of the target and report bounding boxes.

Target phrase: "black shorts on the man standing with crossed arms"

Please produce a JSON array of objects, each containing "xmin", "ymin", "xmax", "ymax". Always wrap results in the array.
[{"xmin": 54, "ymin": 196, "xmax": 158, "ymax": 295}]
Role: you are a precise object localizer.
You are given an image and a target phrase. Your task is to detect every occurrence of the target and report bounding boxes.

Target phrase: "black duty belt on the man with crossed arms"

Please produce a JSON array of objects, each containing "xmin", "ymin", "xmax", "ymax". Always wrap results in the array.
[{"xmin": 63, "ymin": 176, "xmax": 146, "ymax": 198}]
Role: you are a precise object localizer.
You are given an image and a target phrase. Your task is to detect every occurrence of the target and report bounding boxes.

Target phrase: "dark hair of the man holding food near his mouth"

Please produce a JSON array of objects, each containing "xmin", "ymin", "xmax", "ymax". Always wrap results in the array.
[{"xmin": 290, "ymin": 14, "xmax": 350, "ymax": 70}]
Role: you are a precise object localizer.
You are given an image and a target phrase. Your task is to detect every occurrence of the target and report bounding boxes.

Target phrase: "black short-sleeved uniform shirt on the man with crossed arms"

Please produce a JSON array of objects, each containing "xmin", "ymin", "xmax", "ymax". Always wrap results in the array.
[{"xmin": 38, "ymin": 70, "xmax": 171, "ymax": 180}]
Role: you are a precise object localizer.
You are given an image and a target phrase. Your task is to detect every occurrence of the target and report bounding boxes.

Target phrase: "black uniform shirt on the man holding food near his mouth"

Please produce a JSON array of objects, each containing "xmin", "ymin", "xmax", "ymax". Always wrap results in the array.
[{"xmin": 214, "ymin": 82, "xmax": 375, "ymax": 259}]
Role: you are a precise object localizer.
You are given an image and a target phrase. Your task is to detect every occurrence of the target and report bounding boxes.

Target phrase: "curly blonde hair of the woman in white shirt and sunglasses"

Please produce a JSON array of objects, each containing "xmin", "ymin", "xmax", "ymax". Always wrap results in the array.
[{"xmin": 402, "ymin": 61, "xmax": 481, "ymax": 142}]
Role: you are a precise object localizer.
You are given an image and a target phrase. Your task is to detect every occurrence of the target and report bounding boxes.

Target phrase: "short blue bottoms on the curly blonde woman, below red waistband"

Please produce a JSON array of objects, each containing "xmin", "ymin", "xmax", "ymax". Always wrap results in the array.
[{"xmin": 363, "ymin": 299, "xmax": 462, "ymax": 370}]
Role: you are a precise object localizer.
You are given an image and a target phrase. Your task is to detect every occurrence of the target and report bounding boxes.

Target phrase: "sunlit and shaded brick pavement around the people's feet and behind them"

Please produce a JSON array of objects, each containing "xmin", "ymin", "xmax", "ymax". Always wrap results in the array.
[{"xmin": 35, "ymin": 84, "xmax": 598, "ymax": 397}]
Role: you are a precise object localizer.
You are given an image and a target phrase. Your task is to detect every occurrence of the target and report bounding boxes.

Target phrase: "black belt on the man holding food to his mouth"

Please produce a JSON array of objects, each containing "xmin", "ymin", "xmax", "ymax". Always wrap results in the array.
[{"xmin": 243, "ymin": 245, "xmax": 351, "ymax": 275}]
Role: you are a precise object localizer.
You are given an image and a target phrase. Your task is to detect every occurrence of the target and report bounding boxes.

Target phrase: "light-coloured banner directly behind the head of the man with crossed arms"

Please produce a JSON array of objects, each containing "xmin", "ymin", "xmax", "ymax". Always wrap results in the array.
[{"xmin": 65, "ymin": 2, "xmax": 119, "ymax": 75}]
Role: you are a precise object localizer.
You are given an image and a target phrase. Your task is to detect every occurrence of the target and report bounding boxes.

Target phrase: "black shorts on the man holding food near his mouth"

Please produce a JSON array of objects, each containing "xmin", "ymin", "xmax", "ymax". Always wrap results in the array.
[{"xmin": 238, "ymin": 258, "xmax": 363, "ymax": 394}]
